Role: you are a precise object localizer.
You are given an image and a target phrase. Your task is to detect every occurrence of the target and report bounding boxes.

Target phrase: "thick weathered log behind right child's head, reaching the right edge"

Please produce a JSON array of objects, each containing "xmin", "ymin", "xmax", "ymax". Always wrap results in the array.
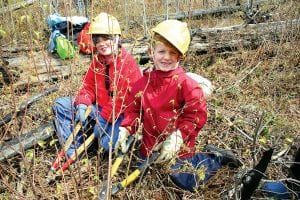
[{"xmin": 123, "ymin": 19, "xmax": 300, "ymax": 56}]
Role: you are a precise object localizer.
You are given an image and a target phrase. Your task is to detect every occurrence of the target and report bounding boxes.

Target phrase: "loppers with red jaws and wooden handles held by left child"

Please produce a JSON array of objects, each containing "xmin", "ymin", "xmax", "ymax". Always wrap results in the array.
[{"xmin": 47, "ymin": 106, "xmax": 95, "ymax": 184}]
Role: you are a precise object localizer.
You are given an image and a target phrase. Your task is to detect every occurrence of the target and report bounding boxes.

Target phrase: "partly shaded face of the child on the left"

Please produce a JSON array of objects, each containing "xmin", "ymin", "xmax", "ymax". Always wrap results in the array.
[{"xmin": 93, "ymin": 35, "xmax": 118, "ymax": 56}]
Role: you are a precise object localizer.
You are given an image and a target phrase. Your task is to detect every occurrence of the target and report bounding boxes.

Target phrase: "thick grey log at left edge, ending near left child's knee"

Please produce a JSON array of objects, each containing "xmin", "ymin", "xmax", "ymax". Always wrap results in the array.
[{"xmin": 0, "ymin": 123, "xmax": 54, "ymax": 162}]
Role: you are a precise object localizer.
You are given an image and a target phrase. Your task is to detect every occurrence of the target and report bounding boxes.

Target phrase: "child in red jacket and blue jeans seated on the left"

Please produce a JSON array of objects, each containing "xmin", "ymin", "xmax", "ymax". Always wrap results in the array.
[{"xmin": 52, "ymin": 13, "xmax": 142, "ymax": 162}]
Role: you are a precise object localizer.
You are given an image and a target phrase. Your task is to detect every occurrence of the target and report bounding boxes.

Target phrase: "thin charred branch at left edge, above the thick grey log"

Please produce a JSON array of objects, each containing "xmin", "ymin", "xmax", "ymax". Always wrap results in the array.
[{"xmin": 0, "ymin": 87, "xmax": 58, "ymax": 127}]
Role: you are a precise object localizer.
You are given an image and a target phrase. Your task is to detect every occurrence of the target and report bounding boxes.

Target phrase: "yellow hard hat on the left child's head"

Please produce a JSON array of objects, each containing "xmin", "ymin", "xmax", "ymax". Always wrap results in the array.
[{"xmin": 89, "ymin": 13, "xmax": 121, "ymax": 35}]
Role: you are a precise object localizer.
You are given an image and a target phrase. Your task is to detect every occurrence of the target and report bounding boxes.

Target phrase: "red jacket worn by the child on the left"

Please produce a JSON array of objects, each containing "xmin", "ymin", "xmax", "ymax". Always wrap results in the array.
[{"xmin": 75, "ymin": 48, "xmax": 142, "ymax": 122}]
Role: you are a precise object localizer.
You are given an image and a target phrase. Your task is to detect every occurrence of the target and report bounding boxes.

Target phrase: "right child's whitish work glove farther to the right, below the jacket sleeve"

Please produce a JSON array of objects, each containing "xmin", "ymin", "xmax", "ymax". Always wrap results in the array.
[{"xmin": 155, "ymin": 130, "xmax": 183, "ymax": 162}]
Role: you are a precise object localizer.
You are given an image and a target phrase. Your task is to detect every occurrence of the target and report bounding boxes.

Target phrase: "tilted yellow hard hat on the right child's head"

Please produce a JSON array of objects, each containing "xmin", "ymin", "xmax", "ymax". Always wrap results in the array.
[{"xmin": 151, "ymin": 19, "xmax": 191, "ymax": 55}]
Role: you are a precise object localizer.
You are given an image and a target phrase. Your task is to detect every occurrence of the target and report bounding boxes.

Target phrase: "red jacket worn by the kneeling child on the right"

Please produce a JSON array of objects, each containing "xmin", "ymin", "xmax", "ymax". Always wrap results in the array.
[{"xmin": 121, "ymin": 67, "xmax": 207, "ymax": 158}]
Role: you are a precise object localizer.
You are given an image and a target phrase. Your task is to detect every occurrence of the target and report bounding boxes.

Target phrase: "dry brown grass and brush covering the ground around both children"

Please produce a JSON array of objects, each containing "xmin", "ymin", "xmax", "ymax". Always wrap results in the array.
[{"xmin": 0, "ymin": 1, "xmax": 300, "ymax": 199}]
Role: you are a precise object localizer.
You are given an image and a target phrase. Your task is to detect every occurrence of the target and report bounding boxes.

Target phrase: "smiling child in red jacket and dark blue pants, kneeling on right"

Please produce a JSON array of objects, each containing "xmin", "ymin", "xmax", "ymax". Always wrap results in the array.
[{"xmin": 116, "ymin": 20, "xmax": 240, "ymax": 191}]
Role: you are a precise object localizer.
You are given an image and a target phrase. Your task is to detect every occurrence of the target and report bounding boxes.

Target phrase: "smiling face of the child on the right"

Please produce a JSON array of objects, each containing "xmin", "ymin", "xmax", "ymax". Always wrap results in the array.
[{"xmin": 153, "ymin": 42, "xmax": 181, "ymax": 72}]
